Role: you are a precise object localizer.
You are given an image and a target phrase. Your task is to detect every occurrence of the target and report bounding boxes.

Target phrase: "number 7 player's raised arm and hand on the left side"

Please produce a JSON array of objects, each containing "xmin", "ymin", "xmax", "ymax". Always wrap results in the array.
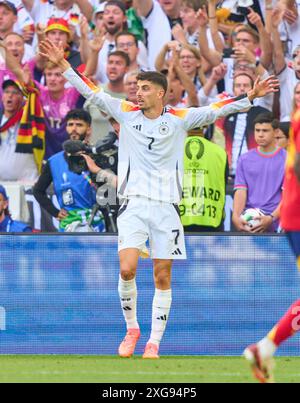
[{"xmin": 39, "ymin": 39, "xmax": 122, "ymax": 121}]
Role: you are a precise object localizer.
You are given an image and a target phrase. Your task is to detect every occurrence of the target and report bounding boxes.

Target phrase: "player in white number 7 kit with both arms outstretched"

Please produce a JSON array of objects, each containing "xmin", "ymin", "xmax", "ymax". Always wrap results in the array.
[{"xmin": 40, "ymin": 40, "xmax": 278, "ymax": 358}]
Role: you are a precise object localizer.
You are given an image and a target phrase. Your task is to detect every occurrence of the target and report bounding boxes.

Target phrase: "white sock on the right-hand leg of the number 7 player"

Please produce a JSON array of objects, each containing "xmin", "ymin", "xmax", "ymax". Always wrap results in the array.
[{"xmin": 149, "ymin": 288, "xmax": 172, "ymax": 346}]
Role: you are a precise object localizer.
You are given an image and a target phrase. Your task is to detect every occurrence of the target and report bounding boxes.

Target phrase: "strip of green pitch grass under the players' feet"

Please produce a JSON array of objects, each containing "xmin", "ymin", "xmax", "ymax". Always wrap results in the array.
[{"xmin": 0, "ymin": 355, "xmax": 300, "ymax": 383}]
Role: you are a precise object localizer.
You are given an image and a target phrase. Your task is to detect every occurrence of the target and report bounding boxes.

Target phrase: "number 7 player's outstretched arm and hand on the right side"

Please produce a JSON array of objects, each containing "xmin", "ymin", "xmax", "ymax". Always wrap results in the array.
[{"xmin": 184, "ymin": 76, "xmax": 279, "ymax": 130}]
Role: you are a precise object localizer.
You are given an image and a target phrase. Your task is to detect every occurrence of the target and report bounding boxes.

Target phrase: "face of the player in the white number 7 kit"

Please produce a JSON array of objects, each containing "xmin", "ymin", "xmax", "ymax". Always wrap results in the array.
[{"xmin": 136, "ymin": 80, "xmax": 164, "ymax": 110}]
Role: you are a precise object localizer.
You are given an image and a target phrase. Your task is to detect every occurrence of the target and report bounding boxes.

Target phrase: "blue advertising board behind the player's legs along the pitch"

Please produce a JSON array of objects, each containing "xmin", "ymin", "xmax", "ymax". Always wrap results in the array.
[{"xmin": 0, "ymin": 234, "xmax": 300, "ymax": 355}]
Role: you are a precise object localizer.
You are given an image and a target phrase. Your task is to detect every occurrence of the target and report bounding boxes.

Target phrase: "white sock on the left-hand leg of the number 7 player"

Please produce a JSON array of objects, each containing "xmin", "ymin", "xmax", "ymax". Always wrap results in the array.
[{"xmin": 118, "ymin": 276, "xmax": 139, "ymax": 330}]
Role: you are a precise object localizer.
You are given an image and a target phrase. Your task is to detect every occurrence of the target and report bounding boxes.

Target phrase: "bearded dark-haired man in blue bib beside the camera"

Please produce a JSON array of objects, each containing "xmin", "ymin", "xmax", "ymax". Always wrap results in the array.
[{"xmin": 33, "ymin": 109, "xmax": 110, "ymax": 232}]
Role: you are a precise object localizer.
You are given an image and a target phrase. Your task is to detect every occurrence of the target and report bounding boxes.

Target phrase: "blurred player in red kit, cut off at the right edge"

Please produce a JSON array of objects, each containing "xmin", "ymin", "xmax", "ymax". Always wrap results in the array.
[{"xmin": 244, "ymin": 109, "xmax": 300, "ymax": 383}]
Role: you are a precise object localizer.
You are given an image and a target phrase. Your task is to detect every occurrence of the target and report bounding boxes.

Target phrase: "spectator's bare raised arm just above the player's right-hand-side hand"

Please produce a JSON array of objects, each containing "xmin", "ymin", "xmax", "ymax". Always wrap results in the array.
[{"xmin": 248, "ymin": 8, "xmax": 273, "ymax": 69}]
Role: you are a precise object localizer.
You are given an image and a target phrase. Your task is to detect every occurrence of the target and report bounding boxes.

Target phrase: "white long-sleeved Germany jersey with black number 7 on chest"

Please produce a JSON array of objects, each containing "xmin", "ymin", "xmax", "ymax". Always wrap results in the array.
[{"xmin": 64, "ymin": 68, "xmax": 251, "ymax": 203}]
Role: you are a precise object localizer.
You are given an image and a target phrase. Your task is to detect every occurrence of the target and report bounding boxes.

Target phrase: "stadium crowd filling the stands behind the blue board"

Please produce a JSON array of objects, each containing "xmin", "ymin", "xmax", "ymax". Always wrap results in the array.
[{"xmin": 0, "ymin": 0, "xmax": 300, "ymax": 232}]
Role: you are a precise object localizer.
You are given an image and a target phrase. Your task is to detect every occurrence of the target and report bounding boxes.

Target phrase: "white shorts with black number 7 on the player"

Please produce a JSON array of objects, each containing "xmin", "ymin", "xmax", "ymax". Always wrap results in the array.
[{"xmin": 117, "ymin": 197, "xmax": 186, "ymax": 259}]
